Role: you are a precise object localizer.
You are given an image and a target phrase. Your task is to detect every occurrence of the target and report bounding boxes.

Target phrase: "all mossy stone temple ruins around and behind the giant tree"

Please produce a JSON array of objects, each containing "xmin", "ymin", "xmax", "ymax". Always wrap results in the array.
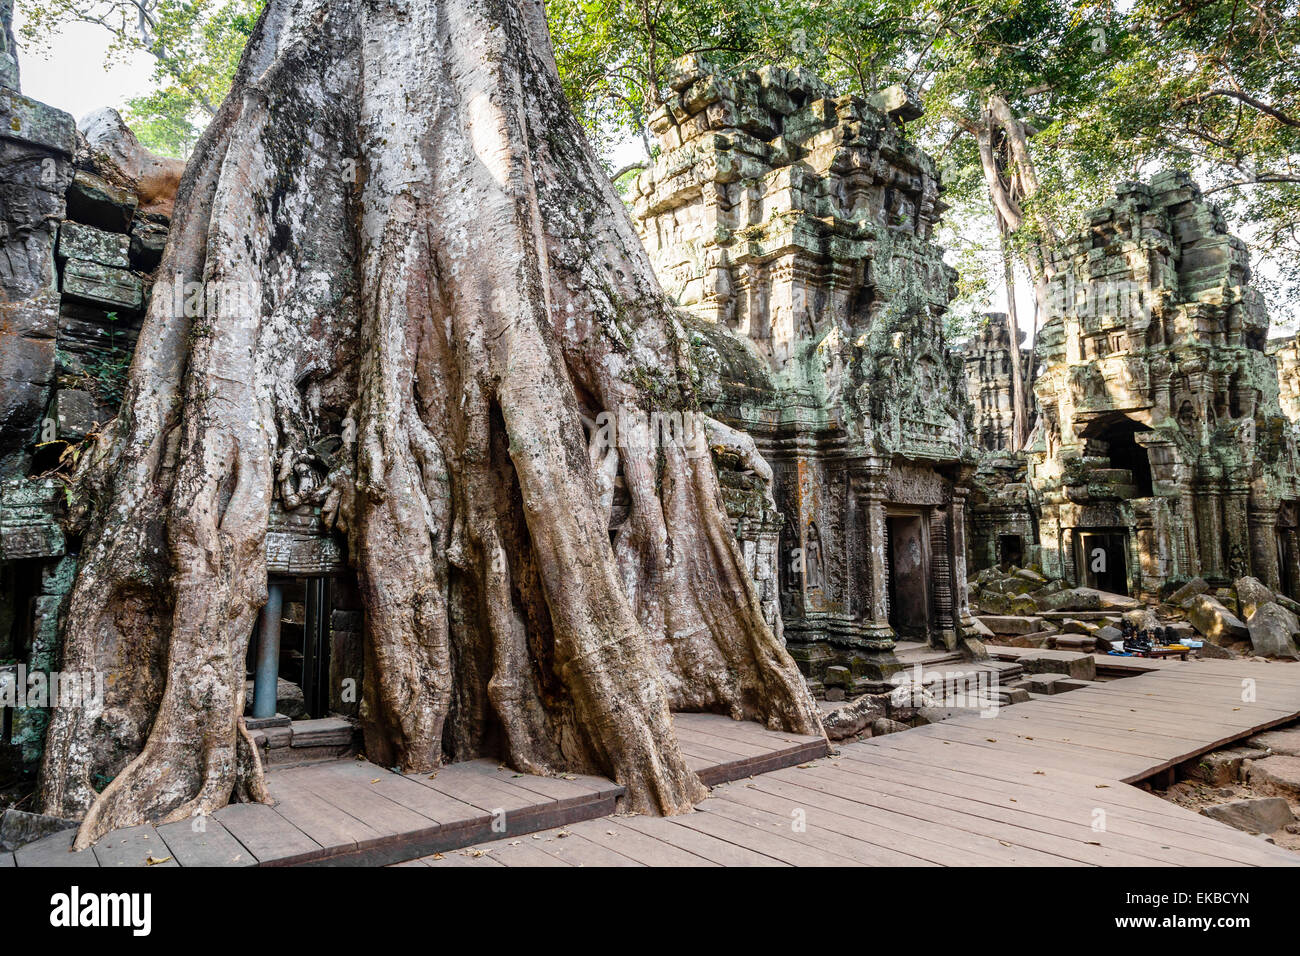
[{"xmin": 0, "ymin": 35, "xmax": 1300, "ymax": 806}]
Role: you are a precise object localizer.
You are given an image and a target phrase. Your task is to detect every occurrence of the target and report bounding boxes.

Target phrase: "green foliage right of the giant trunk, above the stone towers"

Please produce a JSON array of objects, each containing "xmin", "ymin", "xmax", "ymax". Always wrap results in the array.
[{"xmin": 549, "ymin": 0, "xmax": 1300, "ymax": 323}]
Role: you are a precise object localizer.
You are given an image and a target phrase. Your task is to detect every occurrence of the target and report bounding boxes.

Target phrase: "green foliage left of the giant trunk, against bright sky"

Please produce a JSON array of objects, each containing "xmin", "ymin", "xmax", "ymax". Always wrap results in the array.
[{"xmin": 18, "ymin": 0, "xmax": 265, "ymax": 157}]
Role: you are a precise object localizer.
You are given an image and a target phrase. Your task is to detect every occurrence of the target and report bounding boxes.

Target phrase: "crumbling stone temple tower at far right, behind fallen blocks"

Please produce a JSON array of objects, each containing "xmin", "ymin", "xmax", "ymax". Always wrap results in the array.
[{"xmin": 980, "ymin": 173, "xmax": 1300, "ymax": 597}]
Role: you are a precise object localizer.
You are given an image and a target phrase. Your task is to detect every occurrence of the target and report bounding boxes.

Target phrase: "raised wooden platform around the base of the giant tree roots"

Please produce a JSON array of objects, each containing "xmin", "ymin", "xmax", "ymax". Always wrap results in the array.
[{"xmin": 0, "ymin": 714, "xmax": 828, "ymax": 868}]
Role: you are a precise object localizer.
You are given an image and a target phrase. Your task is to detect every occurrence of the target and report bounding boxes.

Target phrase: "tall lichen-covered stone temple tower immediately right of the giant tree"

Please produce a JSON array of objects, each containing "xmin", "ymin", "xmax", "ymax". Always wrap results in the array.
[{"xmin": 631, "ymin": 57, "xmax": 975, "ymax": 682}]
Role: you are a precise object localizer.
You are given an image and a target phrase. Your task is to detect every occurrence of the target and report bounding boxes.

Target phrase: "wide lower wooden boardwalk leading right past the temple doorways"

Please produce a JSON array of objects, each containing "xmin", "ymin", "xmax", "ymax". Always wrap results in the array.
[{"xmin": 413, "ymin": 661, "xmax": 1300, "ymax": 866}]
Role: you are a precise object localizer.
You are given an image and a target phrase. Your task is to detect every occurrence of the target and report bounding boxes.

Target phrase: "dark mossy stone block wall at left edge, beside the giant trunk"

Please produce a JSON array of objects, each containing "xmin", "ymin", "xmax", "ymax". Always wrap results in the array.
[{"xmin": 0, "ymin": 37, "xmax": 179, "ymax": 770}]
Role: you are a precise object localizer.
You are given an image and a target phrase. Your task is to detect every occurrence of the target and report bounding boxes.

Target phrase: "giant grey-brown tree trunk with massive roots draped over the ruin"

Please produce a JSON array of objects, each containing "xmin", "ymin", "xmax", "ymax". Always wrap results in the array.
[{"xmin": 42, "ymin": 0, "xmax": 820, "ymax": 845}]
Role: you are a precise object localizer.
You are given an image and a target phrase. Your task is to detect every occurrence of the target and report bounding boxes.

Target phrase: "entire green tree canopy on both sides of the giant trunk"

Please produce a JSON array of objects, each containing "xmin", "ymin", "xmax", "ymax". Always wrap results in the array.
[{"xmin": 21, "ymin": 0, "xmax": 1300, "ymax": 321}]
